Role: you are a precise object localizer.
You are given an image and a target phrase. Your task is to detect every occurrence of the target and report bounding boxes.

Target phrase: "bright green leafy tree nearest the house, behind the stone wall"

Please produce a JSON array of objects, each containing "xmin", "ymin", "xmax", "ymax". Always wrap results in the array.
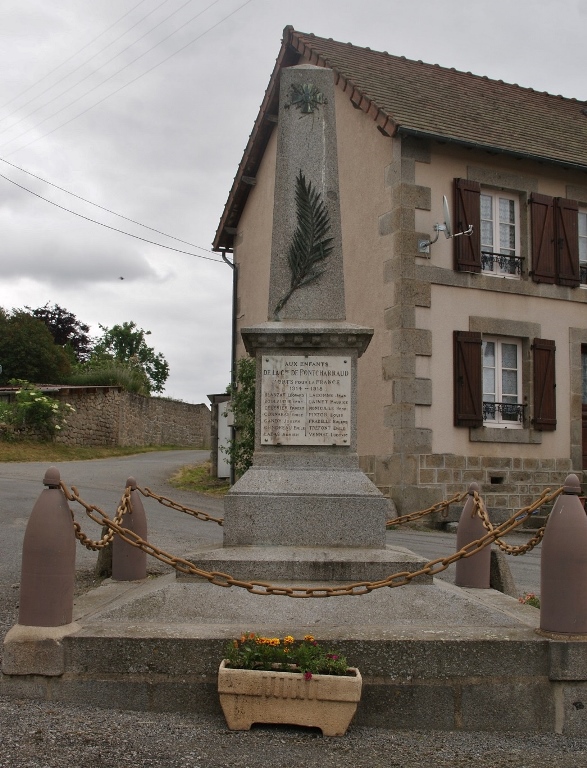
[{"xmin": 89, "ymin": 321, "xmax": 169, "ymax": 394}]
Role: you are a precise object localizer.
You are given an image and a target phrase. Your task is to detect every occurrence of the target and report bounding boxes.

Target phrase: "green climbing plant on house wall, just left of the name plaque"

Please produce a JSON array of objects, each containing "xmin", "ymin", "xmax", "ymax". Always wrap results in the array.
[{"xmin": 222, "ymin": 357, "xmax": 257, "ymax": 477}]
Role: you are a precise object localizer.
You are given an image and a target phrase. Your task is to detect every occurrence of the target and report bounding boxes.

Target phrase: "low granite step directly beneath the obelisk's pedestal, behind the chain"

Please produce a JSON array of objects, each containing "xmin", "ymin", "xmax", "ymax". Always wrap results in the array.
[{"xmin": 177, "ymin": 545, "xmax": 433, "ymax": 586}]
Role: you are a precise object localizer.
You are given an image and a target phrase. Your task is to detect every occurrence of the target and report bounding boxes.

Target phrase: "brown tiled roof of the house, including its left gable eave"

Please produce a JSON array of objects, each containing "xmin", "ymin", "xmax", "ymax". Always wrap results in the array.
[{"xmin": 214, "ymin": 27, "xmax": 587, "ymax": 249}]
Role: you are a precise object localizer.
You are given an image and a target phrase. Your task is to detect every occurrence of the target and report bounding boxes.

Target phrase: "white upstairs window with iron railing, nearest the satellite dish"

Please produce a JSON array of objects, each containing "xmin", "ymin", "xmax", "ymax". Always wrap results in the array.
[{"xmin": 480, "ymin": 190, "xmax": 522, "ymax": 277}]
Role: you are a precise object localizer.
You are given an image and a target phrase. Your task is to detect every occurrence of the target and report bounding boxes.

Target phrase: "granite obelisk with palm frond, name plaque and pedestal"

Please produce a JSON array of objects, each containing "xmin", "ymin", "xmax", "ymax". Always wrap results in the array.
[{"xmin": 224, "ymin": 65, "xmax": 388, "ymax": 549}]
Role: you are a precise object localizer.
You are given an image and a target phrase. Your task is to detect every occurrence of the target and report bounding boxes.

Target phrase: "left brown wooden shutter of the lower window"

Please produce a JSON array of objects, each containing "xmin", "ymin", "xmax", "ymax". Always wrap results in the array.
[{"xmin": 453, "ymin": 331, "xmax": 483, "ymax": 427}]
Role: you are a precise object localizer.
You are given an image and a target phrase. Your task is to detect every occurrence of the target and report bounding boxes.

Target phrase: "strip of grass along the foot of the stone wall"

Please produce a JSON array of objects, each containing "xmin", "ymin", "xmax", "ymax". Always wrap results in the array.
[{"xmin": 0, "ymin": 441, "xmax": 198, "ymax": 461}]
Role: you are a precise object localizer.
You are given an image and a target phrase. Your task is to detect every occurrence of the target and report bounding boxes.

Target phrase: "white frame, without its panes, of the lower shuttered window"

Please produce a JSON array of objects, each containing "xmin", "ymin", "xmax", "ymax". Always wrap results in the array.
[{"xmin": 481, "ymin": 335, "xmax": 525, "ymax": 429}]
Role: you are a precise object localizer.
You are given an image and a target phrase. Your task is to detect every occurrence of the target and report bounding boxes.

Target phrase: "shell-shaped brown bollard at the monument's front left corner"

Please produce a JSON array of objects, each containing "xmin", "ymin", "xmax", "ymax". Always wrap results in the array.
[{"xmin": 18, "ymin": 467, "xmax": 75, "ymax": 627}]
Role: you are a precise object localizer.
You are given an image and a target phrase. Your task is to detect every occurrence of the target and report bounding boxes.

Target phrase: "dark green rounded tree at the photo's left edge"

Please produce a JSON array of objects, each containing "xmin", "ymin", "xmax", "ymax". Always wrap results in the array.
[{"xmin": 0, "ymin": 307, "xmax": 71, "ymax": 384}]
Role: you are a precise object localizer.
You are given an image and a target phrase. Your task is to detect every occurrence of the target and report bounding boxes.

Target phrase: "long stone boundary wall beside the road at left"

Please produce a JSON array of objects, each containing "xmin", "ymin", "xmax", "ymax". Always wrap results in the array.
[{"xmin": 51, "ymin": 387, "xmax": 211, "ymax": 448}]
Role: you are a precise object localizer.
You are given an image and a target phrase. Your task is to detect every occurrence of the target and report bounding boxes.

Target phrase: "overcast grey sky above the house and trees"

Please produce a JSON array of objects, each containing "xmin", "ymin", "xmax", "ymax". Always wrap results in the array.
[{"xmin": 0, "ymin": 0, "xmax": 587, "ymax": 402}]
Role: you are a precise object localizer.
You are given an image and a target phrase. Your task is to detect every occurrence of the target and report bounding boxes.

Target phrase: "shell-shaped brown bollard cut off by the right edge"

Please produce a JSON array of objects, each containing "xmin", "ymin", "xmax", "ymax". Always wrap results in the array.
[{"xmin": 540, "ymin": 475, "xmax": 587, "ymax": 635}]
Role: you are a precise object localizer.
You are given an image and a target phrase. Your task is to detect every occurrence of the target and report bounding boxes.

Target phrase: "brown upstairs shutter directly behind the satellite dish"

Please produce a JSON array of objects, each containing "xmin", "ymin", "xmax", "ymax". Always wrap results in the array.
[{"xmin": 453, "ymin": 179, "xmax": 481, "ymax": 272}]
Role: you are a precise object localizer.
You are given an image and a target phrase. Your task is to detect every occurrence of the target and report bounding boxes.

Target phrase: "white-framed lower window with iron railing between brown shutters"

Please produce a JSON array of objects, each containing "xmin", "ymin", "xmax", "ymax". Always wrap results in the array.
[{"xmin": 482, "ymin": 337, "xmax": 524, "ymax": 427}]
